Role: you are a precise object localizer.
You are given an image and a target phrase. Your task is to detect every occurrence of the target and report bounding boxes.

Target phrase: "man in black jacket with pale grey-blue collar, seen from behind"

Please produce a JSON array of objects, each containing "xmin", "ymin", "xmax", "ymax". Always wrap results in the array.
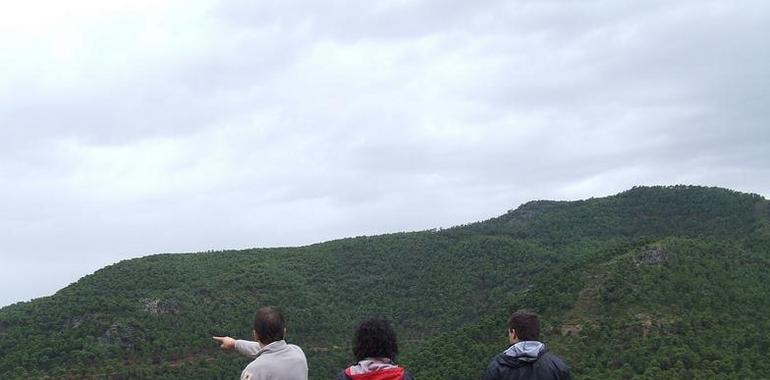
[{"xmin": 484, "ymin": 310, "xmax": 572, "ymax": 380}]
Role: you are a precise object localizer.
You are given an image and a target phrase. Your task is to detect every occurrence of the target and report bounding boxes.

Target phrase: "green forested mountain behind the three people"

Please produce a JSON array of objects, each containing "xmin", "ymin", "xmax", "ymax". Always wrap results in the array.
[{"xmin": 0, "ymin": 186, "xmax": 770, "ymax": 380}]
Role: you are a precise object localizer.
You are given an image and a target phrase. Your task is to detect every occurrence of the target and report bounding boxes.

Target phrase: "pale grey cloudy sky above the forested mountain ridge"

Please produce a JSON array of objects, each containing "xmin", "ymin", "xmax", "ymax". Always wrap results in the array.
[{"xmin": 0, "ymin": 0, "xmax": 770, "ymax": 305}]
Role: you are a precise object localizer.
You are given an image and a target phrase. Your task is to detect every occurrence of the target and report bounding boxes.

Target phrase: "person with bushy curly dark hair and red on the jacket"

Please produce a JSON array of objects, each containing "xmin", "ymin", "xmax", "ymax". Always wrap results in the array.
[{"xmin": 337, "ymin": 318, "xmax": 414, "ymax": 380}]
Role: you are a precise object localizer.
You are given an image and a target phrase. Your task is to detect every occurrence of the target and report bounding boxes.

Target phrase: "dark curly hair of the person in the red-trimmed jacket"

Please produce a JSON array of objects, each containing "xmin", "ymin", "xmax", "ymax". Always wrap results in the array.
[{"xmin": 353, "ymin": 318, "xmax": 398, "ymax": 361}]
